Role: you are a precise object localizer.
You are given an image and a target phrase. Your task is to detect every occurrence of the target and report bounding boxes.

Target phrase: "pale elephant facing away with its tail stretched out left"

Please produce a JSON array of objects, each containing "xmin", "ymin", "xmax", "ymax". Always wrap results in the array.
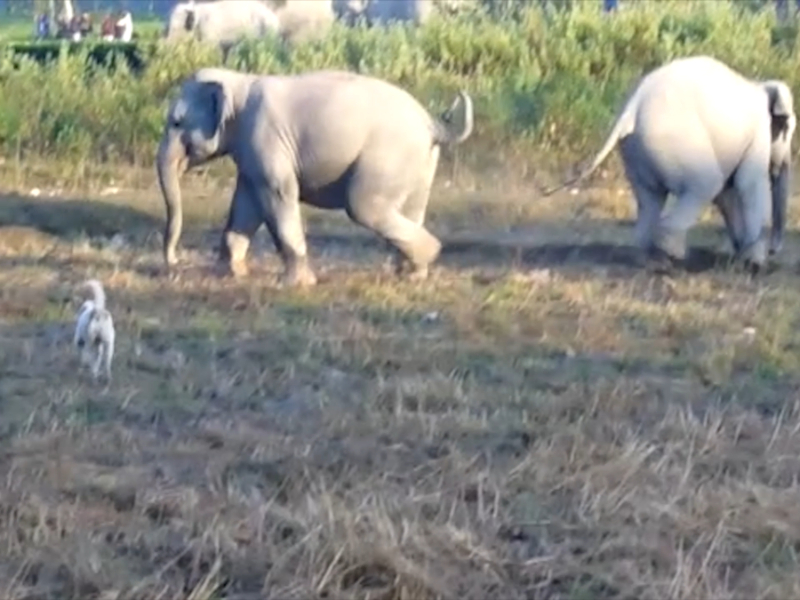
[{"xmin": 545, "ymin": 56, "xmax": 796, "ymax": 268}]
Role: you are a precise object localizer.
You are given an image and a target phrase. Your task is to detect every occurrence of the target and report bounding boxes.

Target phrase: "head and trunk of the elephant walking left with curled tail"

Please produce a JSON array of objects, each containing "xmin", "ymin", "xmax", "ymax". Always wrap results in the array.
[{"xmin": 156, "ymin": 69, "xmax": 247, "ymax": 266}]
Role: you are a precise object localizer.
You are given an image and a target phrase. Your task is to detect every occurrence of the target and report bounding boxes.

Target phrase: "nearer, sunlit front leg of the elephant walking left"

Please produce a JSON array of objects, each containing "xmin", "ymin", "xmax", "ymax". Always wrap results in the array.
[{"xmin": 259, "ymin": 173, "xmax": 317, "ymax": 287}]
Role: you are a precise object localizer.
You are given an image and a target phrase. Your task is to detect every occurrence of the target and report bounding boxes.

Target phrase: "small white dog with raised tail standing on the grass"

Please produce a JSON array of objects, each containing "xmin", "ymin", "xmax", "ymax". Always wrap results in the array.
[{"xmin": 74, "ymin": 279, "xmax": 115, "ymax": 381}]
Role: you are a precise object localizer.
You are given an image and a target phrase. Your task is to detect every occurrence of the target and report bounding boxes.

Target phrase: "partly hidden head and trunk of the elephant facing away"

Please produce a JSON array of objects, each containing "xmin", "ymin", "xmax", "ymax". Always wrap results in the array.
[{"xmin": 761, "ymin": 80, "xmax": 797, "ymax": 254}]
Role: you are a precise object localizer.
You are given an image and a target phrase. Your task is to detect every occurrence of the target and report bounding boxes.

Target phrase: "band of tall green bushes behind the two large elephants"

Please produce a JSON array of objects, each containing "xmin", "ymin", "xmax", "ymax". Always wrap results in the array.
[{"xmin": 0, "ymin": 0, "xmax": 800, "ymax": 171}]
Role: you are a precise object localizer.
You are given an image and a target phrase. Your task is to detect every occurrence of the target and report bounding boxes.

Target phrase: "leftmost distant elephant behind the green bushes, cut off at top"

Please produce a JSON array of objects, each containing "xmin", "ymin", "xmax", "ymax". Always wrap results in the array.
[{"xmin": 165, "ymin": 0, "xmax": 280, "ymax": 52}]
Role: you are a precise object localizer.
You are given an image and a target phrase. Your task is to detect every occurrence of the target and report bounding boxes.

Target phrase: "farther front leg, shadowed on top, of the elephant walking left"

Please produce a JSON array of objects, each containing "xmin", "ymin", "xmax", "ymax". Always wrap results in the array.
[{"xmin": 219, "ymin": 177, "xmax": 262, "ymax": 277}]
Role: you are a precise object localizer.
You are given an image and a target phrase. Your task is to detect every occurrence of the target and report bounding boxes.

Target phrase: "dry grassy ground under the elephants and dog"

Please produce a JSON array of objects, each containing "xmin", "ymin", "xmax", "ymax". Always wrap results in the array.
[{"xmin": 0, "ymin": 161, "xmax": 800, "ymax": 600}]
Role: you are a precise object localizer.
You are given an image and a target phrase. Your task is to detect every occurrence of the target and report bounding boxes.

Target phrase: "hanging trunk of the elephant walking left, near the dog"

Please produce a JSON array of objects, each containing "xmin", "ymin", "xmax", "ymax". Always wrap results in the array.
[{"xmin": 156, "ymin": 134, "xmax": 187, "ymax": 268}]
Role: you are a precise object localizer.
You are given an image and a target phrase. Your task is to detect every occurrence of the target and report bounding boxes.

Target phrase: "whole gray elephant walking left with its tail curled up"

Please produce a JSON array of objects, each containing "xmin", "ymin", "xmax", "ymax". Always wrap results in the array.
[{"xmin": 156, "ymin": 68, "xmax": 473, "ymax": 285}]
